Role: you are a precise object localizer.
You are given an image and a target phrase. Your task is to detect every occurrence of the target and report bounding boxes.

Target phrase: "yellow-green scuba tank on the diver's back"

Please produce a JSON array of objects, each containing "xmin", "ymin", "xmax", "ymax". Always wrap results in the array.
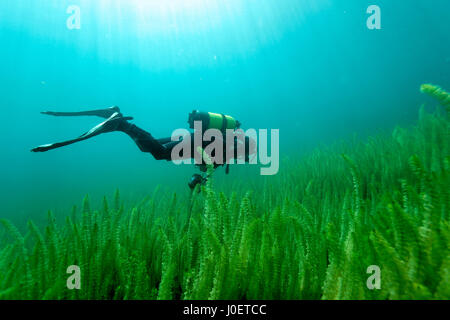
[{"xmin": 188, "ymin": 110, "xmax": 241, "ymax": 132}]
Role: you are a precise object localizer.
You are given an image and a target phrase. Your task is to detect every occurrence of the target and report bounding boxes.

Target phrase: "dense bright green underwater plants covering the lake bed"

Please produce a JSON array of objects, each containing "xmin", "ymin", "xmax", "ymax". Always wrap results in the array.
[{"xmin": 0, "ymin": 85, "xmax": 450, "ymax": 299}]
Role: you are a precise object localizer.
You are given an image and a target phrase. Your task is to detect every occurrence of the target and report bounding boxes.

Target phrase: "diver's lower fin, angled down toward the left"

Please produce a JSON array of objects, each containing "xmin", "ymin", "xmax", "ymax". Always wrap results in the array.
[{"xmin": 31, "ymin": 112, "xmax": 133, "ymax": 152}]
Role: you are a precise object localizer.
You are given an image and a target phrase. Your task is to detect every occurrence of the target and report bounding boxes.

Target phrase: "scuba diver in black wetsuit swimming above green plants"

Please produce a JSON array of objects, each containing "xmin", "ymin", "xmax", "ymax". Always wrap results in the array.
[{"xmin": 31, "ymin": 106, "xmax": 256, "ymax": 191}]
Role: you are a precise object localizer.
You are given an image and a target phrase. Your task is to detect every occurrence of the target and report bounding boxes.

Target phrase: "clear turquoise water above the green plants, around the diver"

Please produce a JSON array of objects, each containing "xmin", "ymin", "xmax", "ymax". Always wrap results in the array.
[{"xmin": 0, "ymin": 0, "xmax": 450, "ymax": 221}]
